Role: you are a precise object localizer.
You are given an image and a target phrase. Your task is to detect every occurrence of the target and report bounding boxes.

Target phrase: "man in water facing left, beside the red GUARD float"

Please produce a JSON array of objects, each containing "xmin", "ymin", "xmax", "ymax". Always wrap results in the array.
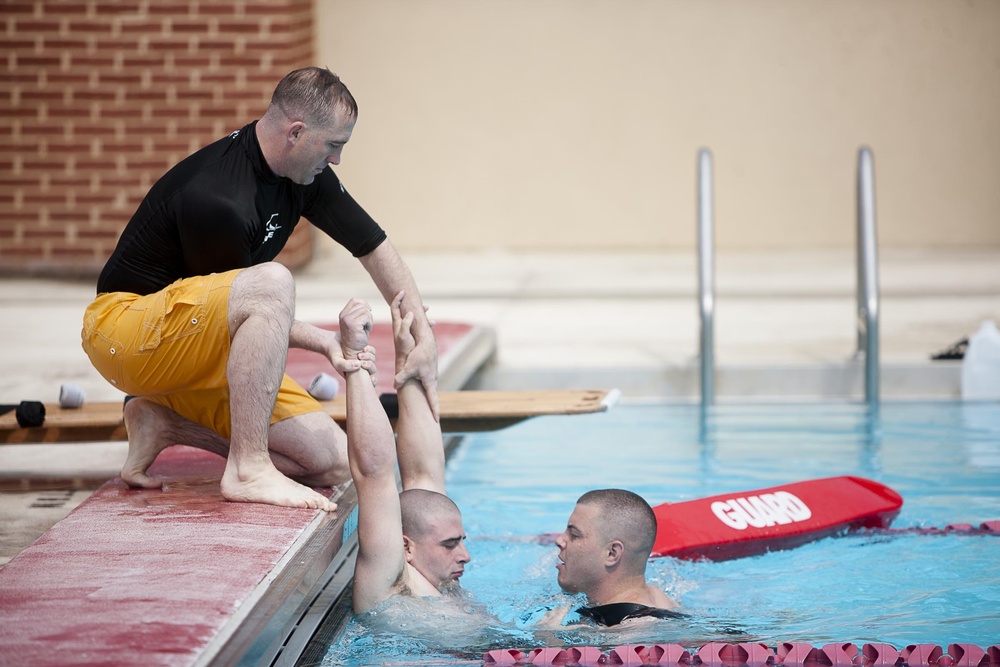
[{"xmin": 540, "ymin": 489, "xmax": 681, "ymax": 628}]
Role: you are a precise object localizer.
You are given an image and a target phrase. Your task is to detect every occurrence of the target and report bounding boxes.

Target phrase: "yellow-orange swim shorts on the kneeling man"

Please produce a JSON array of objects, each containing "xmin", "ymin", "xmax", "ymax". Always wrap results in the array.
[{"xmin": 81, "ymin": 269, "xmax": 323, "ymax": 438}]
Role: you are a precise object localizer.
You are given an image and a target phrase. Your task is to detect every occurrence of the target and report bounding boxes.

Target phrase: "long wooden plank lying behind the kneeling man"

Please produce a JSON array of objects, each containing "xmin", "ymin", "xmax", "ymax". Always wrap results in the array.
[{"xmin": 0, "ymin": 389, "xmax": 617, "ymax": 444}]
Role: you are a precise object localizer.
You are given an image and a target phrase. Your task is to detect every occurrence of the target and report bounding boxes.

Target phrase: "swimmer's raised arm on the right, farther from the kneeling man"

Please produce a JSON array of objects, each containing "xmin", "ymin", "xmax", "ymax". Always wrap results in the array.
[{"xmin": 390, "ymin": 292, "xmax": 445, "ymax": 494}]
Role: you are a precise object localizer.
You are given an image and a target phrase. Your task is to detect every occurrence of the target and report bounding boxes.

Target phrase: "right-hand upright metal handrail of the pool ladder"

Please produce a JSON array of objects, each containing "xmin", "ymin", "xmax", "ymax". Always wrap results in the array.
[{"xmin": 855, "ymin": 146, "xmax": 879, "ymax": 403}]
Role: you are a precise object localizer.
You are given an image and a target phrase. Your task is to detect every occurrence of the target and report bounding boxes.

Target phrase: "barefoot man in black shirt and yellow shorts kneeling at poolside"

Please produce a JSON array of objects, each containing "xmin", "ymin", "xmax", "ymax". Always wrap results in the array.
[{"xmin": 82, "ymin": 67, "xmax": 437, "ymax": 511}]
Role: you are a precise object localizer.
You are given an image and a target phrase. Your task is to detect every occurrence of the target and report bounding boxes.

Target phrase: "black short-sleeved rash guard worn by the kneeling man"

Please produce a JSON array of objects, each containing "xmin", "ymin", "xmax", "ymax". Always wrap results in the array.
[{"xmin": 97, "ymin": 121, "xmax": 386, "ymax": 294}]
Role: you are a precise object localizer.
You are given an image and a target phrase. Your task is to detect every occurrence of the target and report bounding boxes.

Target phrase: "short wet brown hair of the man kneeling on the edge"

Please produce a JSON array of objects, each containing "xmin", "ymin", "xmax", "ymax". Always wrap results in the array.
[{"xmin": 271, "ymin": 67, "xmax": 358, "ymax": 125}]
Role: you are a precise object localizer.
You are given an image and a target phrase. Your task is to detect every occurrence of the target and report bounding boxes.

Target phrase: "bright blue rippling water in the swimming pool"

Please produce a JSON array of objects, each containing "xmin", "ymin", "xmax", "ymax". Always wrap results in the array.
[{"xmin": 327, "ymin": 402, "xmax": 1000, "ymax": 665}]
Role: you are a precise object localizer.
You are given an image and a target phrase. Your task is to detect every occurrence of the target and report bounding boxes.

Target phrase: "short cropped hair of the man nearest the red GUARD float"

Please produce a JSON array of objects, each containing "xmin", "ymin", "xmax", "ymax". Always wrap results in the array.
[{"xmin": 576, "ymin": 489, "xmax": 656, "ymax": 568}]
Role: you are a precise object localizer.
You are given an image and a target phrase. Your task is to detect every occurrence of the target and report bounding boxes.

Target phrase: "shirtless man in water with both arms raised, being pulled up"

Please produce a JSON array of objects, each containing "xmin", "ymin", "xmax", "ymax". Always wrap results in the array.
[{"xmin": 340, "ymin": 293, "xmax": 470, "ymax": 613}]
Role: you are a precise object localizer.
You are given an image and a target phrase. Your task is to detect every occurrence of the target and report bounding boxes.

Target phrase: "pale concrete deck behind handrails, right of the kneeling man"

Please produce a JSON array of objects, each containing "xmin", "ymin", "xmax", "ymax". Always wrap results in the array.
[{"xmin": 356, "ymin": 249, "xmax": 1000, "ymax": 400}]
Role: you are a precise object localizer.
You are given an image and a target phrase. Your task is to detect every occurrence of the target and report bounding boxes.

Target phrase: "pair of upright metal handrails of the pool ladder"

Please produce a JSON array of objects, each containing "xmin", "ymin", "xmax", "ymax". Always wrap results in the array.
[{"xmin": 698, "ymin": 146, "xmax": 879, "ymax": 406}]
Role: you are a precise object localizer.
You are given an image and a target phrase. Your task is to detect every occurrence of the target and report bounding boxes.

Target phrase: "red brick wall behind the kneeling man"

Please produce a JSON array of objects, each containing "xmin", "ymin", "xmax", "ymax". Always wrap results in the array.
[{"xmin": 0, "ymin": 0, "xmax": 313, "ymax": 275}]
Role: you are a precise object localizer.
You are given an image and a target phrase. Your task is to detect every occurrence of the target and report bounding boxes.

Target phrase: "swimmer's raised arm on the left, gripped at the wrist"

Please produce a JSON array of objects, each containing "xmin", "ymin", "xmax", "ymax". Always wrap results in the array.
[{"xmin": 340, "ymin": 299, "xmax": 406, "ymax": 612}]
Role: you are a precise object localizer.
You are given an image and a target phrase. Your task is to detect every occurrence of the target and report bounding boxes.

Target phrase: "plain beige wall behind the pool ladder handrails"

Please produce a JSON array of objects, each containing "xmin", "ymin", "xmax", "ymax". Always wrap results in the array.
[{"xmin": 315, "ymin": 0, "xmax": 1000, "ymax": 251}]
